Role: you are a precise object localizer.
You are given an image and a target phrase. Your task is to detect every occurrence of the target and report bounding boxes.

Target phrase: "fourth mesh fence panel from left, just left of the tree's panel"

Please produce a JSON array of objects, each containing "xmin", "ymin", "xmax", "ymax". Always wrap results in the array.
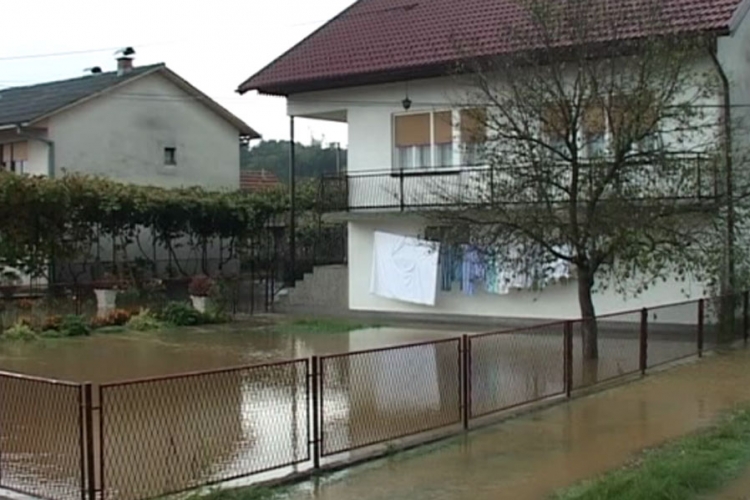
[{"xmin": 469, "ymin": 323, "xmax": 565, "ymax": 418}]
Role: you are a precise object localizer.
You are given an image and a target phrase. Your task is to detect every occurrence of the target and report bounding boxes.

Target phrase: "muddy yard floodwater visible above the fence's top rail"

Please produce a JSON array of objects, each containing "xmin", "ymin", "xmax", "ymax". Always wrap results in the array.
[{"xmin": 0, "ymin": 325, "xmax": 462, "ymax": 383}]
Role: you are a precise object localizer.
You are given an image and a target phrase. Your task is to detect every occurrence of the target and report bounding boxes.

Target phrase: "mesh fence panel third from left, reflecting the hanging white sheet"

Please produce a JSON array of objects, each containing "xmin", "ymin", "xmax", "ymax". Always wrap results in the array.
[{"xmin": 320, "ymin": 339, "xmax": 461, "ymax": 456}]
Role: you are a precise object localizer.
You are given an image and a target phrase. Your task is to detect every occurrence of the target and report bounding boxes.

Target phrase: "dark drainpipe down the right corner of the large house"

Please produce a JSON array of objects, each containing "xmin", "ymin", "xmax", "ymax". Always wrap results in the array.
[{"xmin": 708, "ymin": 39, "xmax": 735, "ymax": 295}]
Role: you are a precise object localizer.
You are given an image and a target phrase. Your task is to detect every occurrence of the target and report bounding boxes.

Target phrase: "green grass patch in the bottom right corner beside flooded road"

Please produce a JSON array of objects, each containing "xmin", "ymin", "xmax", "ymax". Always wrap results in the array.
[{"xmin": 552, "ymin": 409, "xmax": 750, "ymax": 500}]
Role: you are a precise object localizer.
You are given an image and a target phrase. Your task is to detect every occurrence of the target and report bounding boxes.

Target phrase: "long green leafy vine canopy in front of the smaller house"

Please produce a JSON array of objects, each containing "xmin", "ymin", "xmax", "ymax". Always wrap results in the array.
[{"xmin": 0, "ymin": 172, "xmax": 288, "ymax": 276}]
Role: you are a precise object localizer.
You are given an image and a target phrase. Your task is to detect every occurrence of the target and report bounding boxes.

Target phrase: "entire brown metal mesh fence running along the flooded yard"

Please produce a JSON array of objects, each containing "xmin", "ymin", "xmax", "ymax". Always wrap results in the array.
[{"xmin": 0, "ymin": 292, "xmax": 750, "ymax": 500}]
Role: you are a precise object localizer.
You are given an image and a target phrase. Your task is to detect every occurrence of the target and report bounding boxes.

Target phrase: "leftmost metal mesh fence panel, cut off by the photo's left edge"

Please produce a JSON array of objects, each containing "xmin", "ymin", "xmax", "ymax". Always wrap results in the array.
[{"xmin": 0, "ymin": 373, "xmax": 84, "ymax": 499}]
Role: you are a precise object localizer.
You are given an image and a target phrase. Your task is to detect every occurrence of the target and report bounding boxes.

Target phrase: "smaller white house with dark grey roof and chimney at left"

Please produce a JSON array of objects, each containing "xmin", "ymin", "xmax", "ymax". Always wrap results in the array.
[{"xmin": 0, "ymin": 53, "xmax": 260, "ymax": 189}]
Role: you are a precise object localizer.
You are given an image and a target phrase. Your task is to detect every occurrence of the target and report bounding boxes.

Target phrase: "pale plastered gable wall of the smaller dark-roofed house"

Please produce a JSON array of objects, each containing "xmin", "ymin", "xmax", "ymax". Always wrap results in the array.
[{"xmin": 45, "ymin": 74, "xmax": 240, "ymax": 189}]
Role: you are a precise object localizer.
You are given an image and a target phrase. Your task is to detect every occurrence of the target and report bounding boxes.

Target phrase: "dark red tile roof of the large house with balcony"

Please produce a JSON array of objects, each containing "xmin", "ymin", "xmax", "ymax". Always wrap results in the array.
[{"xmin": 238, "ymin": 0, "xmax": 741, "ymax": 95}]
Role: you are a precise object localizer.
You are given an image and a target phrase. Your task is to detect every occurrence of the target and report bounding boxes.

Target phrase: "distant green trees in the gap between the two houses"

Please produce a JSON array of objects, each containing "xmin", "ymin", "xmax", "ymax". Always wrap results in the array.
[{"xmin": 241, "ymin": 141, "xmax": 347, "ymax": 182}]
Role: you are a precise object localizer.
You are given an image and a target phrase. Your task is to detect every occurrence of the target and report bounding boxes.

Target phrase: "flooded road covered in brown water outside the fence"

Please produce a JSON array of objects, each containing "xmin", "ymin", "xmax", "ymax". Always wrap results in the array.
[{"xmin": 288, "ymin": 351, "xmax": 750, "ymax": 500}]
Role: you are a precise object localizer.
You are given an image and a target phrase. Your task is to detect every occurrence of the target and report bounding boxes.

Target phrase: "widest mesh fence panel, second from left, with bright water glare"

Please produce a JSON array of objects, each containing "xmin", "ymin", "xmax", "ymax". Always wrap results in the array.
[{"xmin": 100, "ymin": 360, "xmax": 310, "ymax": 500}]
